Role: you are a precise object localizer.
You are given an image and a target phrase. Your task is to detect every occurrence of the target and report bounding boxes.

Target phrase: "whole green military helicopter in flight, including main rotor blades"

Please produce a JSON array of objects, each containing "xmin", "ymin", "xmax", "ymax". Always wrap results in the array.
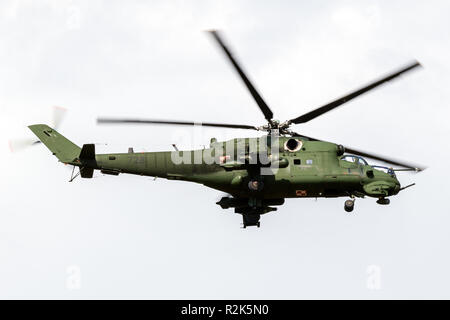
[{"xmin": 29, "ymin": 31, "xmax": 424, "ymax": 228}]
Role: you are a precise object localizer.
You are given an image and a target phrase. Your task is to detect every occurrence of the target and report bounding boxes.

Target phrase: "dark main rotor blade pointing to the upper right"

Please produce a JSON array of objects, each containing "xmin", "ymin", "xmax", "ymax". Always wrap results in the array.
[{"xmin": 290, "ymin": 61, "xmax": 421, "ymax": 123}]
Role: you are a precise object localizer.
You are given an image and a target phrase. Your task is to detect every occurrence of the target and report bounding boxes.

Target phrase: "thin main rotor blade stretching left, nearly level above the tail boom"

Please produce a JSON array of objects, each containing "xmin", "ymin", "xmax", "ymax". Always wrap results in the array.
[{"xmin": 97, "ymin": 118, "xmax": 258, "ymax": 130}]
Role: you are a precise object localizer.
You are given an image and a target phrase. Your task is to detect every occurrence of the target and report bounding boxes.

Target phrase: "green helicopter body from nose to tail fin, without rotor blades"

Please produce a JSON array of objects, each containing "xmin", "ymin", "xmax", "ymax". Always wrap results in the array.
[{"xmin": 29, "ymin": 124, "xmax": 400, "ymax": 227}]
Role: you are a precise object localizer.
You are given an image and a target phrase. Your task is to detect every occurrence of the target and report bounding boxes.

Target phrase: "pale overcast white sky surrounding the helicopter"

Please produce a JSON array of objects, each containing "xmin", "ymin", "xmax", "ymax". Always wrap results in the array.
[{"xmin": 0, "ymin": 1, "xmax": 450, "ymax": 298}]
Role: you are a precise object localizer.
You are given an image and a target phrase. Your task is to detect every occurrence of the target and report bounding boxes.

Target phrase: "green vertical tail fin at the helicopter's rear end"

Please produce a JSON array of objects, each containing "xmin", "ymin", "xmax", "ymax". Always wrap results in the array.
[{"xmin": 28, "ymin": 124, "xmax": 81, "ymax": 163}]
